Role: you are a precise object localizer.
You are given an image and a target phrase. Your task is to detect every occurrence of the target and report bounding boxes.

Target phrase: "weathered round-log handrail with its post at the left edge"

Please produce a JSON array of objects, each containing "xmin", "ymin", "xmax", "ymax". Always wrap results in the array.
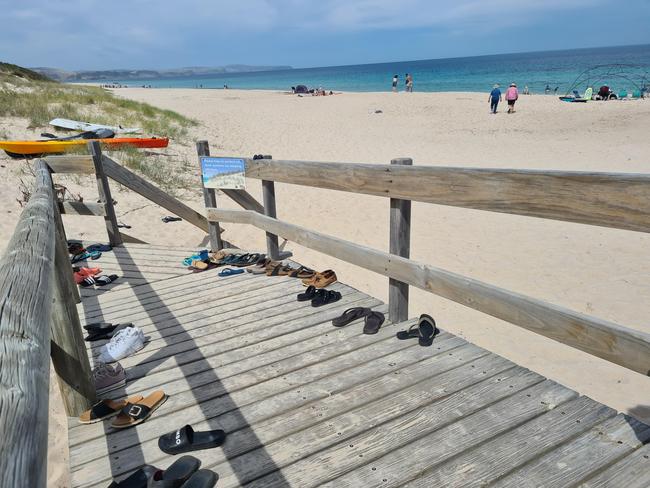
[{"xmin": 0, "ymin": 160, "xmax": 95, "ymax": 487}]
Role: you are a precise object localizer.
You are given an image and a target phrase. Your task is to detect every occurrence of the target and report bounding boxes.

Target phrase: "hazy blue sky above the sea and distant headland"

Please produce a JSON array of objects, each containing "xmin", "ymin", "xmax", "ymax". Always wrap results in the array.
[{"xmin": 0, "ymin": 0, "xmax": 650, "ymax": 69}]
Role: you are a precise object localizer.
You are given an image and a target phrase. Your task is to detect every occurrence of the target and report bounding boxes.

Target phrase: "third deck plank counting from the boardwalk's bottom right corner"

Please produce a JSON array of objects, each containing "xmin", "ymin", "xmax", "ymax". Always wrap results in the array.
[{"xmin": 403, "ymin": 397, "xmax": 624, "ymax": 488}]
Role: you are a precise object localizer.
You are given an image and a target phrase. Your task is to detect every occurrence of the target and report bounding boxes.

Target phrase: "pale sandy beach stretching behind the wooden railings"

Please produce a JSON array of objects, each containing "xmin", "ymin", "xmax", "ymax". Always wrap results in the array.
[{"xmin": 0, "ymin": 88, "xmax": 650, "ymax": 486}]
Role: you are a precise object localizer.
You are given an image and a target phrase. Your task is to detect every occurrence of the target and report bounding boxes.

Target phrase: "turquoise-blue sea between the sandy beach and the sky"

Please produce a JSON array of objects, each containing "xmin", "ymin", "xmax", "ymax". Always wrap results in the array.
[{"xmin": 102, "ymin": 45, "xmax": 650, "ymax": 94}]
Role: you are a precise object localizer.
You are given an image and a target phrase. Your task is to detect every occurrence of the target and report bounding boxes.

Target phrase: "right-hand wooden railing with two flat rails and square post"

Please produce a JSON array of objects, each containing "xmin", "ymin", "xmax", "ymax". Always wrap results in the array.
[{"xmin": 196, "ymin": 143, "xmax": 650, "ymax": 375}]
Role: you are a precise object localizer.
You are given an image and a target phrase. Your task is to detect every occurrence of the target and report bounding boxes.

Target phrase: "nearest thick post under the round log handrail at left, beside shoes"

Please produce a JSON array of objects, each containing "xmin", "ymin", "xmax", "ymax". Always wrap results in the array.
[{"xmin": 50, "ymin": 194, "xmax": 96, "ymax": 417}]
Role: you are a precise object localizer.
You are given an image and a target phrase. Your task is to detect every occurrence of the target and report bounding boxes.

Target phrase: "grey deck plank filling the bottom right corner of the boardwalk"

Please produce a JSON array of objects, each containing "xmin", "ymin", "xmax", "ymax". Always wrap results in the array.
[{"xmin": 580, "ymin": 444, "xmax": 650, "ymax": 488}]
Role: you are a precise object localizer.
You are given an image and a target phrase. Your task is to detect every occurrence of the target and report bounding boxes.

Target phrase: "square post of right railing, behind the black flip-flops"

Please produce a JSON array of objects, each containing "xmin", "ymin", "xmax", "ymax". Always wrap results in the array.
[{"xmin": 388, "ymin": 158, "xmax": 413, "ymax": 324}]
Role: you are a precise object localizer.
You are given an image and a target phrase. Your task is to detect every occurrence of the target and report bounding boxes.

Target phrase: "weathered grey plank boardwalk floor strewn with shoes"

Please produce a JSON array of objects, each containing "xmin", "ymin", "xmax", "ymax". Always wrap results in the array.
[{"xmin": 69, "ymin": 245, "xmax": 650, "ymax": 488}]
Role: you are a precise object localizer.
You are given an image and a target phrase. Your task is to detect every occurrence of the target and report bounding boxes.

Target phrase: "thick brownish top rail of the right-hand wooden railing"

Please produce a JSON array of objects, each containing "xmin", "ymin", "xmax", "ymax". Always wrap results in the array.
[{"xmin": 246, "ymin": 159, "xmax": 650, "ymax": 232}]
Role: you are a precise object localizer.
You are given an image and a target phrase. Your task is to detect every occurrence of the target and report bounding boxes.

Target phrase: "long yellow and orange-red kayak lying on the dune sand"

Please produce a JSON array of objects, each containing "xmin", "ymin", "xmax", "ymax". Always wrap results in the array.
[{"xmin": 0, "ymin": 137, "xmax": 169, "ymax": 158}]
